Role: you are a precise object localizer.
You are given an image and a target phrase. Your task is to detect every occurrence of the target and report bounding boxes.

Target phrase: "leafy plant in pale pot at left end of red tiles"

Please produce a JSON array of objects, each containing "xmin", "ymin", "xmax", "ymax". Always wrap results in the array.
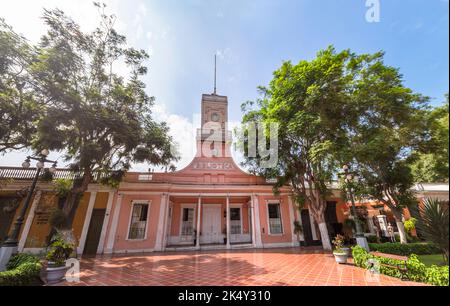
[{"xmin": 46, "ymin": 233, "xmax": 74, "ymax": 284}]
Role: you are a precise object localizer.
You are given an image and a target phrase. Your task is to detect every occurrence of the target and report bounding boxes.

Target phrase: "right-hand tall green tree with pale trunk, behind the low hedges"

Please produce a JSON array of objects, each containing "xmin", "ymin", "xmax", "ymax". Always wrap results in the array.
[{"xmin": 347, "ymin": 52, "xmax": 430, "ymax": 243}]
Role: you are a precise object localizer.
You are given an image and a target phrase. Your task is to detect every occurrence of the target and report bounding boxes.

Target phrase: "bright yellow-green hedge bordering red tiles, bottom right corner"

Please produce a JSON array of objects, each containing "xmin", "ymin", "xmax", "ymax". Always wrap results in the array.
[{"xmin": 352, "ymin": 246, "xmax": 449, "ymax": 286}]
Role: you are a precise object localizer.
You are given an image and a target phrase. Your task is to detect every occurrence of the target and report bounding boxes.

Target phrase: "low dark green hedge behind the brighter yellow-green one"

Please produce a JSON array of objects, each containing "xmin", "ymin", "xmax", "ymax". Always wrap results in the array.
[{"xmin": 369, "ymin": 243, "xmax": 441, "ymax": 256}]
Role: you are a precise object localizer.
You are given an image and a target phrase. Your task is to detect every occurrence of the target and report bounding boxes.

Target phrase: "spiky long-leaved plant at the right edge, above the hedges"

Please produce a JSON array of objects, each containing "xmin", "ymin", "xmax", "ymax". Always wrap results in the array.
[{"xmin": 417, "ymin": 199, "xmax": 449, "ymax": 262}]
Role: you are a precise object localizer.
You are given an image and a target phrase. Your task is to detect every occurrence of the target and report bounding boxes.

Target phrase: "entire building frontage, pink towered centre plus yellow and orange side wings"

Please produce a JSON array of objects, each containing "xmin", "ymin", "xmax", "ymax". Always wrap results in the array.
[{"xmin": 0, "ymin": 94, "xmax": 448, "ymax": 254}]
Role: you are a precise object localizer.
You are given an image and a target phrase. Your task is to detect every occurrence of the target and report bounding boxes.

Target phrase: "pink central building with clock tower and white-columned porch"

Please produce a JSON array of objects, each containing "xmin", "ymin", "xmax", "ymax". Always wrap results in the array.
[{"xmin": 100, "ymin": 94, "xmax": 317, "ymax": 253}]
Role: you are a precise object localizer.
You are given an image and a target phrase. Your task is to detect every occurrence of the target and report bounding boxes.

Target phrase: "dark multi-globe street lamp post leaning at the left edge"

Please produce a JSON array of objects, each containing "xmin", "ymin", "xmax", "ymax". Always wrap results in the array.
[{"xmin": 0, "ymin": 149, "xmax": 56, "ymax": 271}]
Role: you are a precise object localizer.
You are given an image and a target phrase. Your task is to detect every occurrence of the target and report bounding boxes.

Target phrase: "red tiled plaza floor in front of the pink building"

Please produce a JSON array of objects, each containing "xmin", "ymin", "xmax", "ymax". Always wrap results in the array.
[{"xmin": 60, "ymin": 248, "xmax": 422, "ymax": 286}]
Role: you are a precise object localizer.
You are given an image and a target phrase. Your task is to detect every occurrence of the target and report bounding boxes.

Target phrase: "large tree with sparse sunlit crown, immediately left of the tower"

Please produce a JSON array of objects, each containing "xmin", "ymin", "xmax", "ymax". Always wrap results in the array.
[{"xmin": 30, "ymin": 3, "xmax": 176, "ymax": 228}]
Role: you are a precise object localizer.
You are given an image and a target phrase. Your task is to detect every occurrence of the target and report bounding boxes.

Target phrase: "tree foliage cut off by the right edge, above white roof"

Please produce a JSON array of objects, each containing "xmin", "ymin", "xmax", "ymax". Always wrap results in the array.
[{"xmin": 412, "ymin": 94, "xmax": 449, "ymax": 183}]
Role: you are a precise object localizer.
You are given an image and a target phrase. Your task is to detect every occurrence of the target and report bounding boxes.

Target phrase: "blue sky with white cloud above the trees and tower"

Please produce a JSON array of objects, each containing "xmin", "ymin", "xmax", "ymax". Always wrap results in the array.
[{"xmin": 0, "ymin": 0, "xmax": 449, "ymax": 170}]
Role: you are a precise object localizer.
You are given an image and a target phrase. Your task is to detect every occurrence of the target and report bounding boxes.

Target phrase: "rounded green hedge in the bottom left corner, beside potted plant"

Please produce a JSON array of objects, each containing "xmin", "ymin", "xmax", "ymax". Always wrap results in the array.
[{"xmin": 0, "ymin": 254, "xmax": 42, "ymax": 286}]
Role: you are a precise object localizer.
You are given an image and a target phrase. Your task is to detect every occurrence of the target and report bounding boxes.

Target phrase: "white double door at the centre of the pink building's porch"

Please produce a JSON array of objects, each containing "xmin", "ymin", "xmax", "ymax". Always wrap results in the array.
[{"xmin": 200, "ymin": 205, "xmax": 223, "ymax": 244}]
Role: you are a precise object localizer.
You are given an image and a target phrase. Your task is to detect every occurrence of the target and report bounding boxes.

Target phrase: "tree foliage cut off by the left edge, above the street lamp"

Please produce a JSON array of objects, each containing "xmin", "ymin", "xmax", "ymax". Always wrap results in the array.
[{"xmin": 0, "ymin": 18, "xmax": 42, "ymax": 154}]
